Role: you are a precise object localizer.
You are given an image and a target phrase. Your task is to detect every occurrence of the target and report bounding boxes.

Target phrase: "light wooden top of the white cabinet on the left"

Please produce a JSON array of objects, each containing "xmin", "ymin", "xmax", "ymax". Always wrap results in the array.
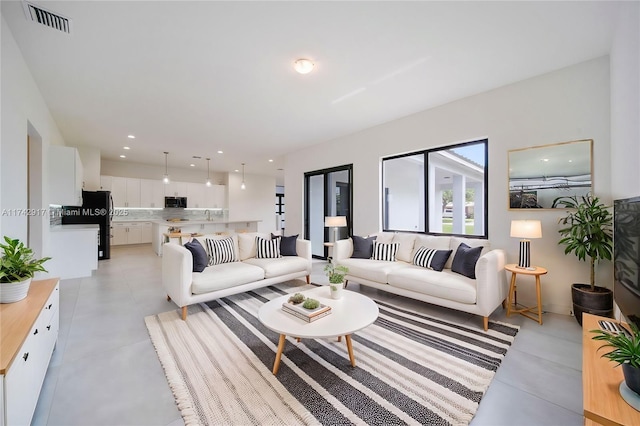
[{"xmin": 0, "ymin": 278, "xmax": 58, "ymax": 374}]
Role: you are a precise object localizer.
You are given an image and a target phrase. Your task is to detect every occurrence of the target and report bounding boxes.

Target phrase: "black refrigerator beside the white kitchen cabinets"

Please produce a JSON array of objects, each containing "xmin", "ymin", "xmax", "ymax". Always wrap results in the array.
[{"xmin": 62, "ymin": 191, "xmax": 113, "ymax": 260}]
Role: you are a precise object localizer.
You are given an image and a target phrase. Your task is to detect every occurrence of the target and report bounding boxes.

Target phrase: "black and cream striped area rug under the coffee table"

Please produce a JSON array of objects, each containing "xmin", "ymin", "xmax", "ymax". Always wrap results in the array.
[{"xmin": 145, "ymin": 281, "xmax": 518, "ymax": 425}]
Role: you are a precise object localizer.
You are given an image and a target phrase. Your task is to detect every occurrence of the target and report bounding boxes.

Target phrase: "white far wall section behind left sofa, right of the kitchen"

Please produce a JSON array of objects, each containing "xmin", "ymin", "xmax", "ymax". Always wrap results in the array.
[{"xmin": 227, "ymin": 173, "xmax": 276, "ymax": 232}]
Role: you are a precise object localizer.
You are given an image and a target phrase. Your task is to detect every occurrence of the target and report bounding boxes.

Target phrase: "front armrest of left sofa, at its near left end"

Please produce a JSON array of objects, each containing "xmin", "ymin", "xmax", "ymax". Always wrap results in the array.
[{"xmin": 162, "ymin": 243, "xmax": 193, "ymax": 307}]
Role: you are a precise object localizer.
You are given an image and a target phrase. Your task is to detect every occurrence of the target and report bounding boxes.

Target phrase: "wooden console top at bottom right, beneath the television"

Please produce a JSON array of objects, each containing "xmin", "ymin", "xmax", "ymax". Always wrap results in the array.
[{"xmin": 582, "ymin": 313, "xmax": 640, "ymax": 426}]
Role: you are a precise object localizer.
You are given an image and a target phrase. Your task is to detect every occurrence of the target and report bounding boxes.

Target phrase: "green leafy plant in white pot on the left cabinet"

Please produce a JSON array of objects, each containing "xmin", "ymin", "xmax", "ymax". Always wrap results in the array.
[{"xmin": 0, "ymin": 237, "xmax": 51, "ymax": 303}]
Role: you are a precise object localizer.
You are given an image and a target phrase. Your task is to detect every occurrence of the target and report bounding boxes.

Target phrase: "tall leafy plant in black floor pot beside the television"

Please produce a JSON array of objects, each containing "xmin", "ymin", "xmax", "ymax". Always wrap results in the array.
[{"xmin": 554, "ymin": 195, "xmax": 613, "ymax": 325}]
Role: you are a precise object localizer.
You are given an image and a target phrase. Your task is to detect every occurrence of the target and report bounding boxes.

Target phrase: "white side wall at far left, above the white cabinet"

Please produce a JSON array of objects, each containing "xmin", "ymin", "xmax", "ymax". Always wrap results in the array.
[{"xmin": 0, "ymin": 17, "xmax": 64, "ymax": 256}]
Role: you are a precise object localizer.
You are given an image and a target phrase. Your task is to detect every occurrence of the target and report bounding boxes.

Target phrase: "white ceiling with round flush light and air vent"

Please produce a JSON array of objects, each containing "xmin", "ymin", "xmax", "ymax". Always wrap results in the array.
[{"xmin": 2, "ymin": 1, "xmax": 620, "ymax": 180}]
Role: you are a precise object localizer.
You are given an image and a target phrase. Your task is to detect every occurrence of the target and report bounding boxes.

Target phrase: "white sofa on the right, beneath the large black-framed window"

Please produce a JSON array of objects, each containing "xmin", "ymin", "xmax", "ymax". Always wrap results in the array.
[{"xmin": 333, "ymin": 232, "xmax": 508, "ymax": 331}]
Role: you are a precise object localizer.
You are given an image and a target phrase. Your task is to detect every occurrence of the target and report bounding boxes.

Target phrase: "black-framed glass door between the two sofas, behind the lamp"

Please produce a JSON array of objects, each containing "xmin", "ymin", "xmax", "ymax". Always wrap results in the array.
[{"xmin": 304, "ymin": 164, "xmax": 353, "ymax": 259}]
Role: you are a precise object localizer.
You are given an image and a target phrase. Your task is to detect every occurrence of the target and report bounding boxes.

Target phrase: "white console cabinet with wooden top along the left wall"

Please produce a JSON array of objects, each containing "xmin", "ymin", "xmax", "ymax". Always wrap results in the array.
[{"xmin": 0, "ymin": 278, "xmax": 60, "ymax": 426}]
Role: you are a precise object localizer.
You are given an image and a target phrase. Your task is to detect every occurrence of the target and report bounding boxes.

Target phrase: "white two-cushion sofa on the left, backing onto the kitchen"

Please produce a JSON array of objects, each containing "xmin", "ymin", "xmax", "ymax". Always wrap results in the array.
[{"xmin": 162, "ymin": 232, "xmax": 311, "ymax": 320}]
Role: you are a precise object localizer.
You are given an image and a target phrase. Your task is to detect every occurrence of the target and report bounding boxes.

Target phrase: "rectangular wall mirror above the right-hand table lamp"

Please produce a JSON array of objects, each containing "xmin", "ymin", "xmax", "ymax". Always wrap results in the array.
[{"xmin": 509, "ymin": 139, "xmax": 593, "ymax": 209}]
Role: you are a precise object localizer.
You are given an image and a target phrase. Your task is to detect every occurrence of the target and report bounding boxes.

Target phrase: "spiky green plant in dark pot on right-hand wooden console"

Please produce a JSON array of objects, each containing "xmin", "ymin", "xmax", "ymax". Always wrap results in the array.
[{"xmin": 591, "ymin": 323, "xmax": 640, "ymax": 394}]
